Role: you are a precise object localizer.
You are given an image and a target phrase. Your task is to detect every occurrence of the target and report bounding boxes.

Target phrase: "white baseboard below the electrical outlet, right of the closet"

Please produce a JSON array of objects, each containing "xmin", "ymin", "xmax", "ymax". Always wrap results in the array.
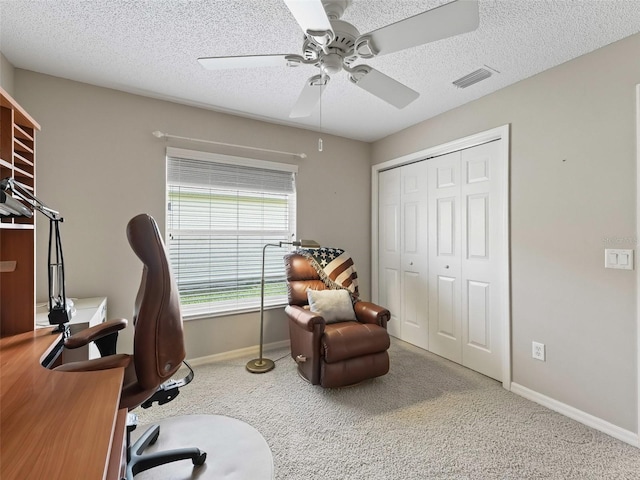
[{"xmin": 511, "ymin": 382, "xmax": 640, "ymax": 447}]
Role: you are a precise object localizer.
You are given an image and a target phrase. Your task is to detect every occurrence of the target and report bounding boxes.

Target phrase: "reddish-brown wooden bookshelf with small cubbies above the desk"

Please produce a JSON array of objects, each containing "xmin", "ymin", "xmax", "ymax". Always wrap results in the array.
[{"xmin": 0, "ymin": 88, "xmax": 40, "ymax": 337}]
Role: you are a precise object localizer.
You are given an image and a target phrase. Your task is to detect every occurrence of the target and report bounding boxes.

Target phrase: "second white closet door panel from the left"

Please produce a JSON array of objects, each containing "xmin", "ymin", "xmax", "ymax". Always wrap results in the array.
[{"xmin": 398, "ymin": 162, "xmax": 429, "ymax": 349}]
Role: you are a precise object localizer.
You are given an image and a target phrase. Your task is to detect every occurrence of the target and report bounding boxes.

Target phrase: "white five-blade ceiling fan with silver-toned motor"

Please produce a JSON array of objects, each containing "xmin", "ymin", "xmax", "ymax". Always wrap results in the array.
[{"xmin": 198, "ymin": 0, "xmax": 479, "ymax": 118}]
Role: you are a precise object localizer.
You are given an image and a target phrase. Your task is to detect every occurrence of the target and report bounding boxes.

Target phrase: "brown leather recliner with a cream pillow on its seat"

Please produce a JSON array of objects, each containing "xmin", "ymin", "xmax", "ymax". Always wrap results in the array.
[{"xmin": 284, "ymin": 253, "xmax": 391, "ymax": 388}]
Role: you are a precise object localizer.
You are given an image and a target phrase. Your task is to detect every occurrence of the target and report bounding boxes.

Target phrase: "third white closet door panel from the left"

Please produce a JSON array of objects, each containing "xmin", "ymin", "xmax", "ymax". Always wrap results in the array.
[{"xmin": 427, "ymin": 152, "xmax": 462, "ymax": 363}]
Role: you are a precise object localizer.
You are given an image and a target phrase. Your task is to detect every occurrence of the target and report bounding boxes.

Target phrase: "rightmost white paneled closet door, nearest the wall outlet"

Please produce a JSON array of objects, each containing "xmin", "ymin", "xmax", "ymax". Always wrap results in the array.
[{"xmin": 461, "ymin": 142, "xmax": 504, "ymax": 379}]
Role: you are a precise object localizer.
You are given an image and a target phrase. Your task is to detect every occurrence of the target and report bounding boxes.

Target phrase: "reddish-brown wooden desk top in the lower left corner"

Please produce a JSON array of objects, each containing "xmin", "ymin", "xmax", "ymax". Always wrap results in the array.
[{"xmin": 0, "ymin": 328, "xmax": 124, "ymax": 480}]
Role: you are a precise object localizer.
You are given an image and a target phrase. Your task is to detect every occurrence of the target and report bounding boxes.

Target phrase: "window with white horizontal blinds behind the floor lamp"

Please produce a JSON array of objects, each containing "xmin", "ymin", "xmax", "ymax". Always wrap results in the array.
[{"xmin": 167, "ymin": 148, "xmax": 297, "ymax": 317}]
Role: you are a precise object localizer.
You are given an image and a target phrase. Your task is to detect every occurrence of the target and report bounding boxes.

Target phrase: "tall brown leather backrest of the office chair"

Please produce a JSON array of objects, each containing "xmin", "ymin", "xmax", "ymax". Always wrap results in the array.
[{"xmin": 127, "ymin": 214, "xmax": 186, "ymax": 389}]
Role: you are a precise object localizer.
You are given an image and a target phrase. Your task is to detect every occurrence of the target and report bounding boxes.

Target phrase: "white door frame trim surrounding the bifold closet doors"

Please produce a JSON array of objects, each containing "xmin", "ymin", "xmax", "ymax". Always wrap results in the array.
[{"xmin": 371, "ymin": 124, "xmax": 510, "ymax": 390}]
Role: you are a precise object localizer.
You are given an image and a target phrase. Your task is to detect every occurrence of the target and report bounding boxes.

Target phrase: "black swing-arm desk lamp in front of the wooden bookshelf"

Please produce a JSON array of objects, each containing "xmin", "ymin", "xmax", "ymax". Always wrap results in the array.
[{"xmin": 0, "ymin": 177, "xmax": 71, "ymax": 332}]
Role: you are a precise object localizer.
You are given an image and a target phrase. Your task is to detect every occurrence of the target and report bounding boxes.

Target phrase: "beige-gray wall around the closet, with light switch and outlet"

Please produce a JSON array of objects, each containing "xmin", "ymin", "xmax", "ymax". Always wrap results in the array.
[{"xmin": 372, "ymin": 35, "xmax": 640, "ymax": 432}]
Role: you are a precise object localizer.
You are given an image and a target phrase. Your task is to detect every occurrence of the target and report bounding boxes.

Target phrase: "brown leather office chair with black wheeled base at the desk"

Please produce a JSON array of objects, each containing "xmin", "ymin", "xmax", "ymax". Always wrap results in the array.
[{"xmin": 56, "ymin": 214, "xmax": 207, "ymax": 480}]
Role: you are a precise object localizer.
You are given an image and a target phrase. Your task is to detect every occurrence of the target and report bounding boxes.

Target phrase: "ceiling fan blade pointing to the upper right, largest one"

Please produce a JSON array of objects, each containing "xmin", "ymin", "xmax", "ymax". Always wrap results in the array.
[{"xmin": 355, "ymin": 0, "xmax": 480, "ymax": 58}]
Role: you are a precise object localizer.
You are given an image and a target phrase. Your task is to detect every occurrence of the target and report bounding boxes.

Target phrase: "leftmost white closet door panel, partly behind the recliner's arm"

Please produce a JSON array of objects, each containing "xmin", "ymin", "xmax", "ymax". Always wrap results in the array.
[{"xmin": 378, "ymin": 168, "xmax": 402, "ymax": 338}]
